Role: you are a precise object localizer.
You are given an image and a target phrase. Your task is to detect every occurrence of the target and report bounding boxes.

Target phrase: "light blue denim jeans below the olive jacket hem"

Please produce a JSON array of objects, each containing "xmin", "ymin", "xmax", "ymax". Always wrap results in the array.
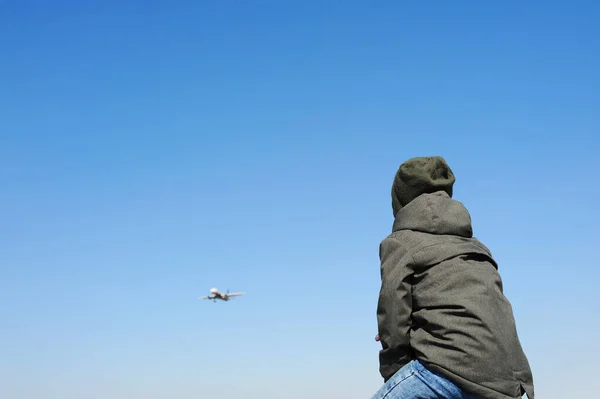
[{"xmin": 371, "ymin": 360, "xmax": 475, "ymax": 399}]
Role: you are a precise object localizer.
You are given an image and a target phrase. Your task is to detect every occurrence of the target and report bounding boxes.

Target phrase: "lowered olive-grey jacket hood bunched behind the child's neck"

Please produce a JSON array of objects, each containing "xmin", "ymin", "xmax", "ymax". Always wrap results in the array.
[{"xmin": 392, "ymin": 191, "xmax": 473, "ymax": 238}]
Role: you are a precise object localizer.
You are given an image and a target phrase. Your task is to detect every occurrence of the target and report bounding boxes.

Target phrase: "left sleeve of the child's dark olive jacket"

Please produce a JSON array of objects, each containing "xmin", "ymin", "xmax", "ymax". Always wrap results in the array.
[{"xmin": 377, "ymin": 237, "xmax": 412, "ymax": 382}]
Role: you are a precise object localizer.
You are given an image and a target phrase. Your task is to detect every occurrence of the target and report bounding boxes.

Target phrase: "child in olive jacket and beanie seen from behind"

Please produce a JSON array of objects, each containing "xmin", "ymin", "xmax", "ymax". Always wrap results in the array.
[{"xmin": 372, "ymin": 157, "xmax": 534, "ymax": 399}]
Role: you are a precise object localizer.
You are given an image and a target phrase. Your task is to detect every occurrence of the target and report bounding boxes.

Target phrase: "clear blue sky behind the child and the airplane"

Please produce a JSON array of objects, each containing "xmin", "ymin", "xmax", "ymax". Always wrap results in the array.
[{"xmin": 0, "ymin": 0, "xmax": 600, "ymax": 399}]
